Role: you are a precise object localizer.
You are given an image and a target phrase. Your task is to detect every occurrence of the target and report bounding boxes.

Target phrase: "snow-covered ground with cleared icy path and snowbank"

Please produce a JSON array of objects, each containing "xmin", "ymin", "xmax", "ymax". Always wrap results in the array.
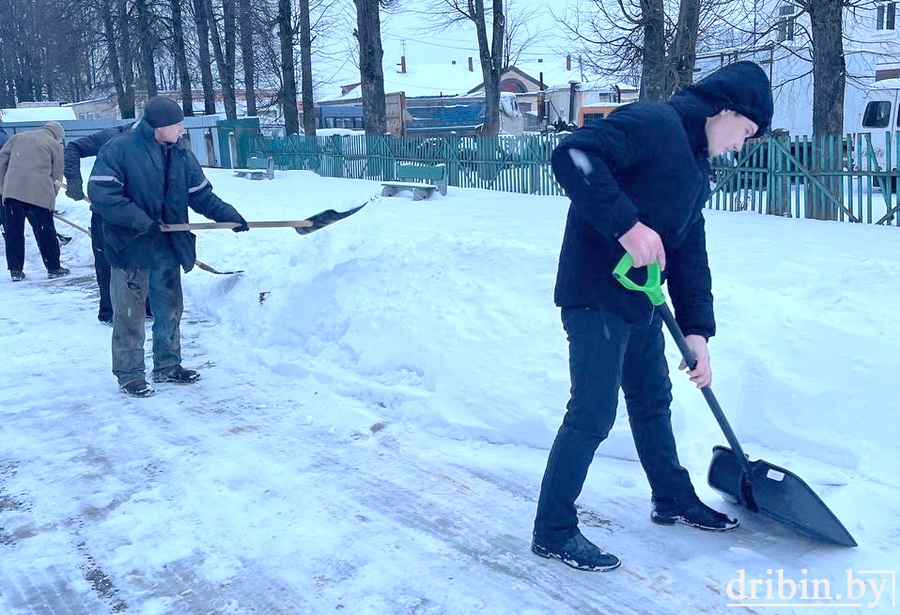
[{"xmin": 0, "ymin": 165, "xmax": 900, "ymax": 615}]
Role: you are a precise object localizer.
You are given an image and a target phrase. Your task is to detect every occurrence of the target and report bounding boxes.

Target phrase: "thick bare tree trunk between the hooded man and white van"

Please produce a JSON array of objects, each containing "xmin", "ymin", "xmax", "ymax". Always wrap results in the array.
[{"xmin": 807, "ymin": 0, "xmax": 848, "ymax": 220}]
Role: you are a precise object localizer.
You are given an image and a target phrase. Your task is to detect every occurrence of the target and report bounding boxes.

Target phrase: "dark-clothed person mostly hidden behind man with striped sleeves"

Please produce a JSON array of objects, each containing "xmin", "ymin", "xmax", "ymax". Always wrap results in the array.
[{"xmin": 63, "ymin": 119, "xmax": 153, "ymax": 326}]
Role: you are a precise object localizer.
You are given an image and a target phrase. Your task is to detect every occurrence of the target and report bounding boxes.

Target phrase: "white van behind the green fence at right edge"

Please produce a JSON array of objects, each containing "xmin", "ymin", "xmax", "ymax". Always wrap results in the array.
[{"xmin": 853, "ymin": 79, "xmax": 900, "ymax": 170}]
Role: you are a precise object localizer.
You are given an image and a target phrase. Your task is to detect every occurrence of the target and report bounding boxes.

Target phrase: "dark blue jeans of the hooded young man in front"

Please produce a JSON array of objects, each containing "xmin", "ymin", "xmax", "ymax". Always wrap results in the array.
[{"xmin": 534, "ymin": 308, "xmax": 693, "ymax": 544}]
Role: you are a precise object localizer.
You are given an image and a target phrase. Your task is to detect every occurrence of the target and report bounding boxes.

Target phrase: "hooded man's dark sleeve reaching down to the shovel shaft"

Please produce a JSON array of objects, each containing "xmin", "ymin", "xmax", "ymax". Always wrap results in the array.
[{"xmin": 666, "ymin": 215, "xmax": 716, "ymax": 339}]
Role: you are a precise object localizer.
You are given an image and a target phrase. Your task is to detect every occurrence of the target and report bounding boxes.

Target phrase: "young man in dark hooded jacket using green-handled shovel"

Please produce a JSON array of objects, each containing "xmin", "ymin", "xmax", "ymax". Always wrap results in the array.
[{"xmin": 532, "ymin": 62, "xmax": 773, "ymax": 571}]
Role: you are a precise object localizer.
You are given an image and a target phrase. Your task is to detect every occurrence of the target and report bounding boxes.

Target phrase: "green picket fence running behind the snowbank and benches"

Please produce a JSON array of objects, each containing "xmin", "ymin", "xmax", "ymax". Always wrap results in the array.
[{"xmin": 240, "ymin": 132, "xmax": 900, "ymax": 226}]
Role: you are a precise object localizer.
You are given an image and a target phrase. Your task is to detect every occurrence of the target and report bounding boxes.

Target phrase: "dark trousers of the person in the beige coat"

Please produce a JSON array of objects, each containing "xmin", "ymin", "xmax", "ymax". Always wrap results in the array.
[{"xmin": 3, "ymin": 199, "xmax": 59, "ymax": 271}]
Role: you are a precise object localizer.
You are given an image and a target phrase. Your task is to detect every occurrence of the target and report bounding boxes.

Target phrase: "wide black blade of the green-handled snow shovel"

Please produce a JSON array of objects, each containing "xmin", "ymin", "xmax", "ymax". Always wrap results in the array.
[{"xmin": 707, "ymin": 446, "xmax": 857, "ymax": 547}]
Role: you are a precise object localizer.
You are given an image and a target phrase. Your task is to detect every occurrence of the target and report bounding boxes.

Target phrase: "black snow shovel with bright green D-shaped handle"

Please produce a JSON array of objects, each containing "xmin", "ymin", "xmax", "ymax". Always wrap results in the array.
[{"xmin": 613, "ymin": 253, "xmax": 856, "ymax": 547}]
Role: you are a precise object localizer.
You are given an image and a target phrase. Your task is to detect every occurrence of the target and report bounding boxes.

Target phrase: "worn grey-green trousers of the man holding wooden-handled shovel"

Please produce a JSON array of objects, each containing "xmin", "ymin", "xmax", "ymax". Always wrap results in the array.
[{"xmin": 109, "ymin": 254, "xmax": 184, "ymax": 385}]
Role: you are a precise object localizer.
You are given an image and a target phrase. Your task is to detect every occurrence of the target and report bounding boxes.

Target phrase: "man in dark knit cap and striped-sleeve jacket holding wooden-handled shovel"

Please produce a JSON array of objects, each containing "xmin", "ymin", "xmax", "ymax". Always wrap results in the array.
[{"xmin": 88, "ymin": 96, "xmax": 249, "ymax": 397}]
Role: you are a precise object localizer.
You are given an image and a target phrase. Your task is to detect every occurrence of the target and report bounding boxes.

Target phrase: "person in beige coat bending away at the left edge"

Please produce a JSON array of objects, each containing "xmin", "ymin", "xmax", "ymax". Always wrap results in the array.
[{"xmin": 0, "ymin": 122, "xmax": 69, "ymax": 282}]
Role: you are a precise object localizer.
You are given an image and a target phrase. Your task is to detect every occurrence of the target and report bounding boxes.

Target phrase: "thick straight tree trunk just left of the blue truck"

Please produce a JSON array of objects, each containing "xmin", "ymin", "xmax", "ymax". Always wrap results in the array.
[{"xmin": 354, "ymin": 0, "xmax": 387, "ymax": 136}]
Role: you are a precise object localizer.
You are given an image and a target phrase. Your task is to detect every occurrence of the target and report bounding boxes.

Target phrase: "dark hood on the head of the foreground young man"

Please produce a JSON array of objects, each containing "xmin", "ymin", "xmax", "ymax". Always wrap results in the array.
[{"xmin": 685, "ymin": 61, "xmax": 774, "ymax": 137}]
